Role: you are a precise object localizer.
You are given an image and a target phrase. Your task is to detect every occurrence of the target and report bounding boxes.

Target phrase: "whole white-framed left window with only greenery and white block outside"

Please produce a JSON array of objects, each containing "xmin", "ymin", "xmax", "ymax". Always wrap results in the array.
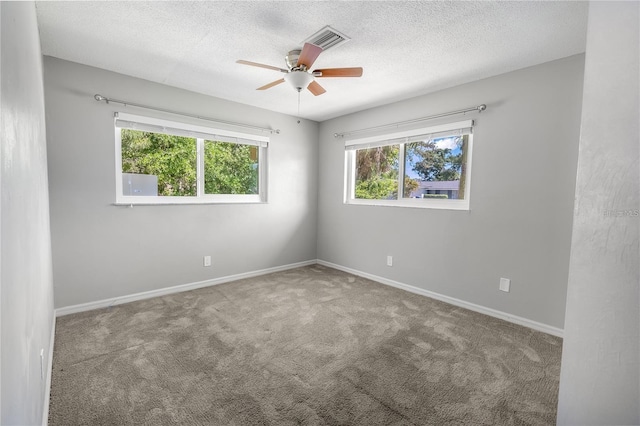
[{"xmin": 115, "ymin": 113, "xmax": 269, "ymax": 204}]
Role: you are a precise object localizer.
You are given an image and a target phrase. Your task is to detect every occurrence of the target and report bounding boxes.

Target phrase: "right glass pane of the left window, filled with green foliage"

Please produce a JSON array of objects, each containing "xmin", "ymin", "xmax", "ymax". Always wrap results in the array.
[{"xmin": 204, "ymin": 141, "xmax": 259, "ymax": 194}]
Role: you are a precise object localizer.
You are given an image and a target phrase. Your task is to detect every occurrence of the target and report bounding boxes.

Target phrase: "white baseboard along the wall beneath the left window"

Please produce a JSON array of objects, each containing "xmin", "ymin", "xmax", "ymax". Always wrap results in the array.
[{"xmin": 56, "ymin": 259, "xmax": 317, "ymax": 317}]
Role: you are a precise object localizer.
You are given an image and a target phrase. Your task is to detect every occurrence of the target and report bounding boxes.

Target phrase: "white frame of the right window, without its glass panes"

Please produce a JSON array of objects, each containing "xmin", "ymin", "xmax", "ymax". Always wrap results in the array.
[{"xmin": 343, "ymin": 120, "xmax": 475, "ymax": 210}]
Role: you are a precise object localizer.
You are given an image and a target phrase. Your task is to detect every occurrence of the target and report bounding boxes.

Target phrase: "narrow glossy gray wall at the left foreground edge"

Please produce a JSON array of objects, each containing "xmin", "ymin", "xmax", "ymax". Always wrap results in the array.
[{"xmin": 0, "ymin": 2, "xmax": 54, "ymax": 425}]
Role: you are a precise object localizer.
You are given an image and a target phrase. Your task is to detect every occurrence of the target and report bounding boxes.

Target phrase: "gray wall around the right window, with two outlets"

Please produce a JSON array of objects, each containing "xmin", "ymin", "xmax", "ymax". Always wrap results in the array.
[{"xmin": 318, "ymin": 55, "xmax": 584, "ymax": 328}]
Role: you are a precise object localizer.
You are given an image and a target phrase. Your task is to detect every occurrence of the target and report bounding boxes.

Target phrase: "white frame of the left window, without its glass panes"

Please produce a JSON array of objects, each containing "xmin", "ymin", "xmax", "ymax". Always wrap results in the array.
[{"xmin": 113, "ymin": 112, "xmax": 270, "ymax": 205}]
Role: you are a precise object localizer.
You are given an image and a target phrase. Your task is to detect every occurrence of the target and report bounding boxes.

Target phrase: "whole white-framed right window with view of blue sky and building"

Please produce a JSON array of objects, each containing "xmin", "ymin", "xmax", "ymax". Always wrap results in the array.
[{"xmin": 345, "ymin": 120, "xmax": 473, "ymax": 210}]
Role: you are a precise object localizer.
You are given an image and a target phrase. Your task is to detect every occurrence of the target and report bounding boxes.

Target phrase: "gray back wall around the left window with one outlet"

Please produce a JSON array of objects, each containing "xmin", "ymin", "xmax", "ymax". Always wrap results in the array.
[{"xmin": 44, "ymin": 57, "xmax": 318, "ymax": 307}]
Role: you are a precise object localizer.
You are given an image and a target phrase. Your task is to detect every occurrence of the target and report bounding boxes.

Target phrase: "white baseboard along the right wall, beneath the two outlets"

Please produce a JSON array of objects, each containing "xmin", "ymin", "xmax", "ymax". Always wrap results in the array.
[{"xmin": 318, "ymin": 259, "xmax": 564, "ymax": 337}]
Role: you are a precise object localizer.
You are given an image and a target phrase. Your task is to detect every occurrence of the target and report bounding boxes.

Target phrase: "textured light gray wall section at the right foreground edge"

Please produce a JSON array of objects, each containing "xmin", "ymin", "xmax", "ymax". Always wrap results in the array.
[{"xmin": 558, "ymin": 2, "xmax": 640, "ymax": 425}]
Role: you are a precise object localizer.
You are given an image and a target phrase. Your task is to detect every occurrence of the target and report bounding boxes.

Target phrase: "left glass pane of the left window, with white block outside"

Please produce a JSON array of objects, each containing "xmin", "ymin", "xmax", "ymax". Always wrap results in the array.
[{"xmin": 120, "ymin": 129, "xmax": 197, "ymax": 197}]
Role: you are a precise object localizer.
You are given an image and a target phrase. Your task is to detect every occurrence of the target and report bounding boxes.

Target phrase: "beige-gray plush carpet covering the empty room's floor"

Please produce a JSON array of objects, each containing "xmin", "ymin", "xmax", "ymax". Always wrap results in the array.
[{"xmin": 49, "ymin": 265, "xmax": 562, "ymax": 426}]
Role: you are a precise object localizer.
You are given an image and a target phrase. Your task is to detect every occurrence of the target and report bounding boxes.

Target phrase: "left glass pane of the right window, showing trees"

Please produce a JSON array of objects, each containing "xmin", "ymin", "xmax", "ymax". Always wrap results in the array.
[{"xmin": 355, "ymin": 145, "xmax": 400, "ymax": 200}]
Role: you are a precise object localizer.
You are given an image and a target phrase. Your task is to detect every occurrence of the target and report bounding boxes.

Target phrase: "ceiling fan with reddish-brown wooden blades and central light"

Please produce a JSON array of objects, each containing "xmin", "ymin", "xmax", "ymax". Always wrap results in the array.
[{"xmin": 236, "ymin": 43, "xmax": 362, "ymax": 96}]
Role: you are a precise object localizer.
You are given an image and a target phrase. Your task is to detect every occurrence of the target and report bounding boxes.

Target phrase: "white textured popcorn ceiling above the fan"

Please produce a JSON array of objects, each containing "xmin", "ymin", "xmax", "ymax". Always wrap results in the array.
[{"xmin": 36, "ymin": 1, "xmax": 587, "ymax": 121}]
